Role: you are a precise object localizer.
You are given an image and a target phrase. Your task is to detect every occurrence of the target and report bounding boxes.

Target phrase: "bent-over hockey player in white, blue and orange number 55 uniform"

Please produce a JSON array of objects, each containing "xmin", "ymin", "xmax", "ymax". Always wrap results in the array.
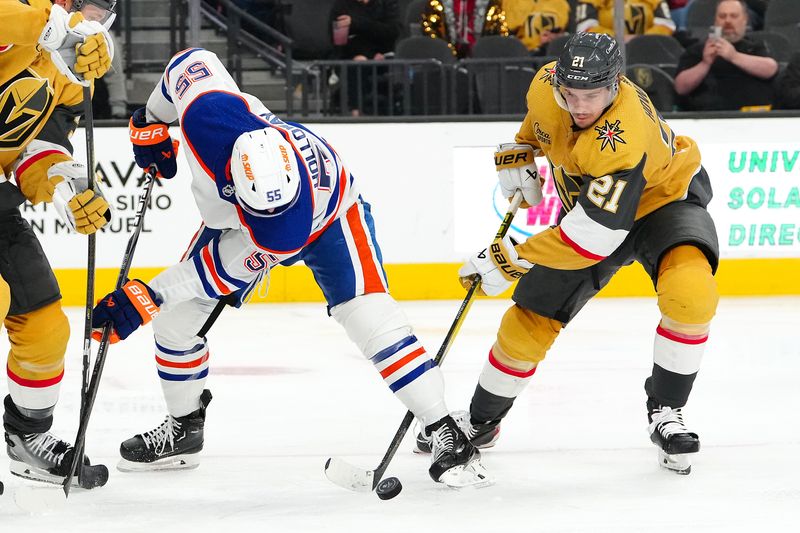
[{"xmin": 93, "ymin": 48, "xmax": 485, "ymax": 486}]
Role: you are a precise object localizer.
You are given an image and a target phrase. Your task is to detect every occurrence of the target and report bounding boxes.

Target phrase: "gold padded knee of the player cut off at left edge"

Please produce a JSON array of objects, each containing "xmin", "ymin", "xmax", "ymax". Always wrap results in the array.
[{"xmin": 6, "ymin": 301, "xmax": 69, "ymax": 379}]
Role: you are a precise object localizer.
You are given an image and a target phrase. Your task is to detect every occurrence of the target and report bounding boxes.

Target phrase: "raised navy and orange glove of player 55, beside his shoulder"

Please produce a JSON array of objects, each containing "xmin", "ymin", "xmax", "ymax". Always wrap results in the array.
[{"xmin": 128, "ymin": 107, "xmax": 178, "ymax": 179}]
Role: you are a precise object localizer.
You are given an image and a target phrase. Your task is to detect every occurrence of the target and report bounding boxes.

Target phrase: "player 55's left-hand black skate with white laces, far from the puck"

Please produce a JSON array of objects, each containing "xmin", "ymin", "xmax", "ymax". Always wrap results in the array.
[{"xmin": 117, "ymin": 389, "xmax": 211, "ymax": 472}]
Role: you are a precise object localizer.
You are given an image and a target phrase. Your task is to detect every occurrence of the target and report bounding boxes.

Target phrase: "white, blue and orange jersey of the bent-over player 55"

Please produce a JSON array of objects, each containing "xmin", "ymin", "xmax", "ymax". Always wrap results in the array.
[{"xmin": 146, "ymin": 48, "xmax": 358, "ymax": 306}]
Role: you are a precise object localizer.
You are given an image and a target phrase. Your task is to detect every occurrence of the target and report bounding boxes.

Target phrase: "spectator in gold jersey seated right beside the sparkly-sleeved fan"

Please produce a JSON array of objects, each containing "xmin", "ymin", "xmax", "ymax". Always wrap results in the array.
[{"xmin": 503, "ymin": 0, "xmax": 570, "ymax": 53}]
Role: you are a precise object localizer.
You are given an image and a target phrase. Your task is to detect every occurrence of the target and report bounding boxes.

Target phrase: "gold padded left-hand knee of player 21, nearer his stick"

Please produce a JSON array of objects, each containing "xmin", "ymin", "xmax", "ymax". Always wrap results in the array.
[{"xmin": 494, "ymin": 305, "xmax": 561, "ymax": 369}]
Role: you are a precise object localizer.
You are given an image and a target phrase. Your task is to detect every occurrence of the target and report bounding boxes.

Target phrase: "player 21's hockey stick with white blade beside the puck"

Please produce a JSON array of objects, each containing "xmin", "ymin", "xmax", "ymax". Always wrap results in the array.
[{"xmin": 325, "ymin": 190, "xmax": 522, "ymax": 492}]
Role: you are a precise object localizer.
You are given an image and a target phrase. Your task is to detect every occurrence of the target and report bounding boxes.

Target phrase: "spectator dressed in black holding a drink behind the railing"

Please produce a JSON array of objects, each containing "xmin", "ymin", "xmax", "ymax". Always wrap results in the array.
[{"xmin": 330, "ymin": 0, "xmax": 402, "ymax": 116}]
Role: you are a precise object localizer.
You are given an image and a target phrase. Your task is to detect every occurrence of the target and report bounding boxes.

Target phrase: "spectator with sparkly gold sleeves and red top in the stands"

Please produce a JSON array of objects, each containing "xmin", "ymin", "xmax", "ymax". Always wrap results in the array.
[{"xmin": 422, "ymin": 0, "xmax": 508, "ymax": 58}]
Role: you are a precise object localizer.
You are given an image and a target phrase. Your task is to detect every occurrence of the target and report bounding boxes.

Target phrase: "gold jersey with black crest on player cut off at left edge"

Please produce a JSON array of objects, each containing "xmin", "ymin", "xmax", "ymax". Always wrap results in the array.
[{"xmin": 0, "ymin": 0, "xmax": 83, "ymax": 169}]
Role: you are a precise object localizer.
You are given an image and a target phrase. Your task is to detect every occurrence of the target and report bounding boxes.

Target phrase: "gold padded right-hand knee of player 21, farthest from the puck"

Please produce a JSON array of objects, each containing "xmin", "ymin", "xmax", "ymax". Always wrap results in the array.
[{"xmin": 656, "ymin": 245, "xmax": 719, "ymax": 326}]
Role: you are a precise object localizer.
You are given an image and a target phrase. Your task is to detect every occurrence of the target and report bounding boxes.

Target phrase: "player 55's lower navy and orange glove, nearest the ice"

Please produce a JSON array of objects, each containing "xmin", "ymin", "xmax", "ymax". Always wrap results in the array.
[{"xmin": 92, "ymin": 279, "xmax": 162, "ymax": 344}]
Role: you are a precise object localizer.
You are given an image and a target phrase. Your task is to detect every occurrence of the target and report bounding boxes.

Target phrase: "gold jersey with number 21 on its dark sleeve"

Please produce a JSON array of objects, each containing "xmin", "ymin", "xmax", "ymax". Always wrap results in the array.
[{"xmin": 516, "ymin": 62, "xmax": 700, "ymax": 270}]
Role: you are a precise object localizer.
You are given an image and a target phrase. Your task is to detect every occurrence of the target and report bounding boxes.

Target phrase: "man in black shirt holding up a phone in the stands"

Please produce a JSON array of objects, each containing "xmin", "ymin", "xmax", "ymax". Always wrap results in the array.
[{"xmin": 675, "ymin": 0, "xmax": 778, "ymax": 111}]
